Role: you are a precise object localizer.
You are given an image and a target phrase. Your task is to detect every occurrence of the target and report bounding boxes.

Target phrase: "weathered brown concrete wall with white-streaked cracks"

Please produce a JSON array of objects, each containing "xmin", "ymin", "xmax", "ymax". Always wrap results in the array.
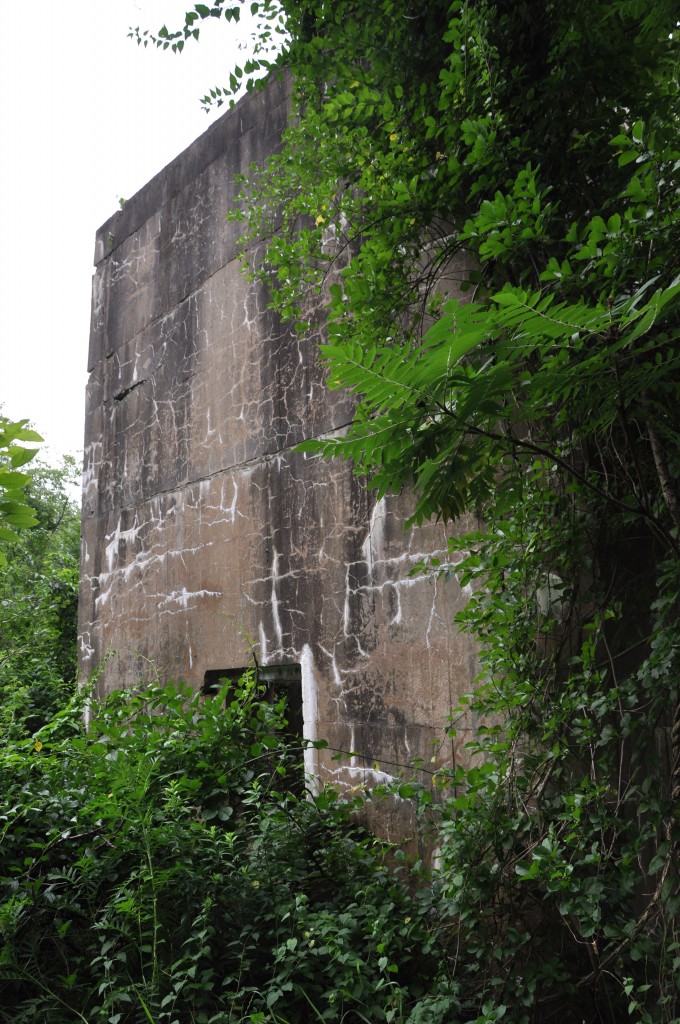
[{"xmin": 80, "ymin": 72, "xmax": 473, "ymax": 815}]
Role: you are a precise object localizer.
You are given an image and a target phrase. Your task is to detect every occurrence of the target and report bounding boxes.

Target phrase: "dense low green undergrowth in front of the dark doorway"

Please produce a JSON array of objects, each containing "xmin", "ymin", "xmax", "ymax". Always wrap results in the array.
[{"xmin": 0, "ymin": 678, "xmax": 436, "ymax": 1024}]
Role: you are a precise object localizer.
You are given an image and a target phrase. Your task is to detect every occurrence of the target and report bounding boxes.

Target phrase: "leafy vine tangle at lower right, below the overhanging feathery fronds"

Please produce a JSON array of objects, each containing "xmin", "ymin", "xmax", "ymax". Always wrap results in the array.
[{"xmin": 409, "ymin": 520, "xmax": 680, "ymax": 1024}]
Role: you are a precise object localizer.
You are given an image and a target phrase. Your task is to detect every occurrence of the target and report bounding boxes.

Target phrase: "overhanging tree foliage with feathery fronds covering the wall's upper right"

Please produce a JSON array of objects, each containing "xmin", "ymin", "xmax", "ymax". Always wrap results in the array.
[{"xmin": 227, "ymin": 3, "xmax": 680, "ymax": 536}]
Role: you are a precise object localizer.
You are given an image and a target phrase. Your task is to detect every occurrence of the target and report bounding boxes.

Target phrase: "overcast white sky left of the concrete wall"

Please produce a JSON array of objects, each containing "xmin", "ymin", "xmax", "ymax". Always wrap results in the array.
[{"xmin": 0, "ymin": 0, "xmax": 253, "ymax": 462}]
